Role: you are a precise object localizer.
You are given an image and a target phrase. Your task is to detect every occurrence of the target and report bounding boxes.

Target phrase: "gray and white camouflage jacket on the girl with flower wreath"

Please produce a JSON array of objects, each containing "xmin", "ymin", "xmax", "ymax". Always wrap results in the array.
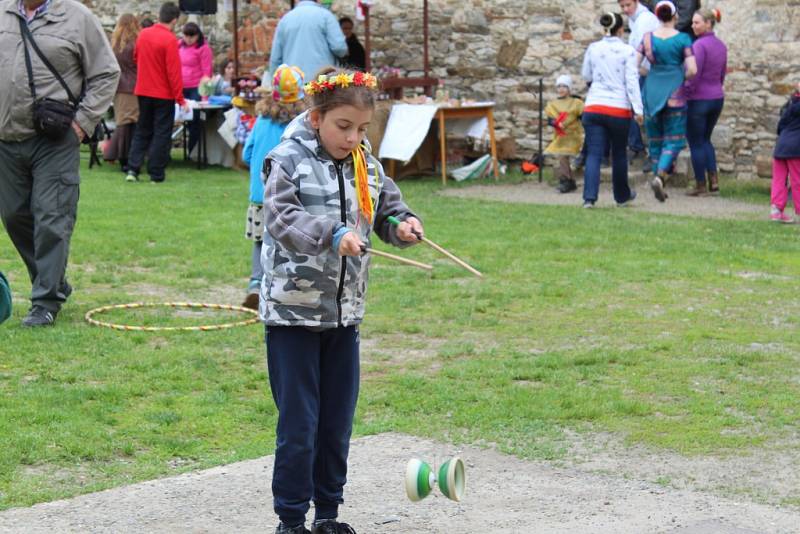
[{"xmin": 260, "ymin": 113, "xmax": 413, "ymax": 328}]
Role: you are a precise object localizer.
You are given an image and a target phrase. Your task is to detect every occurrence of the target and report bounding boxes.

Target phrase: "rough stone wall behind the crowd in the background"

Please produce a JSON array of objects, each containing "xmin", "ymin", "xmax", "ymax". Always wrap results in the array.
[{"xmin": 85, "ymin": 0, "xmax": 800, "ymax": 178}]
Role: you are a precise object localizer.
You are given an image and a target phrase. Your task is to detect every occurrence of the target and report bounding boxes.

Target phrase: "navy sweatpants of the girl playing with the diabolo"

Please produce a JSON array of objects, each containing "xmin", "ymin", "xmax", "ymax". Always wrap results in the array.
[{"xmin": 266, "ymin": 326, "xmax": 359, "ymax": 526}]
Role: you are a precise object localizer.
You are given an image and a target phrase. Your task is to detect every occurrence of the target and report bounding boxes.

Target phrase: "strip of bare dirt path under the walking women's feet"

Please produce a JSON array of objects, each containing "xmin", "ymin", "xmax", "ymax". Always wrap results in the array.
[{"xmin": 441, "ymin": 175, "xmax": 769, "ymax": 220}]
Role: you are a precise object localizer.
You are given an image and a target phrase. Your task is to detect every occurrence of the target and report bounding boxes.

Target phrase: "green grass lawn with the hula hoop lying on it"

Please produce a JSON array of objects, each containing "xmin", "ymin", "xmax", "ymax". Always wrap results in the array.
[{"xmin": 0, "ymin": 156, "xmax": 800, "ymax": 509}]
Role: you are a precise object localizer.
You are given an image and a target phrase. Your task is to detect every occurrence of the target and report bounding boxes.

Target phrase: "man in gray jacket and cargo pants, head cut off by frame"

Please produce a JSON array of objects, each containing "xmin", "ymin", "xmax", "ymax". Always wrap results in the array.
[{"xmin": 0, "ymin": 0, "xmax": 119, "ymax": 326}]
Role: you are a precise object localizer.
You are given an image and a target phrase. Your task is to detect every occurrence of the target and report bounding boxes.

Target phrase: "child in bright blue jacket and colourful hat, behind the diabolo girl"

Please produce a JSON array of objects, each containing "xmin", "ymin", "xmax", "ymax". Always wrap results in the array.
[{"xmin": 242, "ymin": 65, "xmax": 305, "ymax": 310}]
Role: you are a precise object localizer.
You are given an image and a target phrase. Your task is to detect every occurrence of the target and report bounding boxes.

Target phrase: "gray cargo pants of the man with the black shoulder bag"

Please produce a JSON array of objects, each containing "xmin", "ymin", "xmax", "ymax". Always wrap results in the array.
[{"xmin": 0, "ymin": 129, "xmax": 80, "ymax": 312}]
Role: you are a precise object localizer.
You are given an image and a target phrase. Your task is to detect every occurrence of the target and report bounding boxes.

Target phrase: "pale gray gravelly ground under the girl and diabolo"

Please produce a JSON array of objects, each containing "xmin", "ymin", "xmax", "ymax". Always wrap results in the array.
[{"xmin": 0, "ymin": 434, "xmax": 800, "ymax": 534}]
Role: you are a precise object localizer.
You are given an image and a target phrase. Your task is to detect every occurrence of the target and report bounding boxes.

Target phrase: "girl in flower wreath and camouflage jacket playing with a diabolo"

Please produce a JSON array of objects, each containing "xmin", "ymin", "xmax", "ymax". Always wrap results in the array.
[{"xmin": 260, "ymin": 68, "xmax": 423, "ymax": 534}]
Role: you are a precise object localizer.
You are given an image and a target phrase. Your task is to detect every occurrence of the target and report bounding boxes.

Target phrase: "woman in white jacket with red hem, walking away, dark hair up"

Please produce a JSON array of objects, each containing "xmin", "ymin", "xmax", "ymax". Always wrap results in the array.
[{"xmin": 582, "ymin": 13, "xmax": 642, "ymax": 208}]
